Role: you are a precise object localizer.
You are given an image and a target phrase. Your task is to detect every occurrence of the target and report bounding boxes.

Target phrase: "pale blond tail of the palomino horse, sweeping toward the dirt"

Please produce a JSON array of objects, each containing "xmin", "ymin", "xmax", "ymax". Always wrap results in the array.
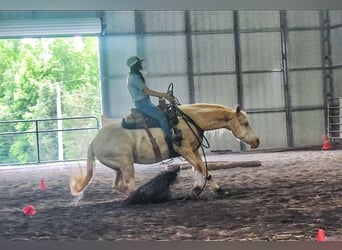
[{"xmin": 70, "ymin": 143, "xmax": 95, "ymax": 196}]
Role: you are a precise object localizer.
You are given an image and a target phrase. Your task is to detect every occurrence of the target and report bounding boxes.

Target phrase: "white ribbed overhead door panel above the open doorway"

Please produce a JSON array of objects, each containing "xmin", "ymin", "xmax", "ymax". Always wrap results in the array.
[{"xmin": 0, "ymin": 18, "xmax": 102, "ymax": 38}]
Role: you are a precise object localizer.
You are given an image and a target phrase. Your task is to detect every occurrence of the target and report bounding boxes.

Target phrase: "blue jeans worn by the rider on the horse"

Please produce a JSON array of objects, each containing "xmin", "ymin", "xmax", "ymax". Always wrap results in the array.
[{"xmin": 134, "ymin": 98, "xmax": 172, "ymax": 140}]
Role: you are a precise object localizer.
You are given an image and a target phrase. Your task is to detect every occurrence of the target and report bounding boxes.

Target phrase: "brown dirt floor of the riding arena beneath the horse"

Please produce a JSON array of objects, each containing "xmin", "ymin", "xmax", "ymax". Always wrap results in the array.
[{"xmin": 0, "ymin": 150, "xmax": 342, "ymax": 241}]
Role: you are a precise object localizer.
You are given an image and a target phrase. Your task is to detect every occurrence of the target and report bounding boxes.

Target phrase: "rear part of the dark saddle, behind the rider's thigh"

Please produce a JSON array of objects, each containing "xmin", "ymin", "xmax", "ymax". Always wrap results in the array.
[{"xmin": 122, "ymin": 108, "xmax": 160, "ymax": 129}]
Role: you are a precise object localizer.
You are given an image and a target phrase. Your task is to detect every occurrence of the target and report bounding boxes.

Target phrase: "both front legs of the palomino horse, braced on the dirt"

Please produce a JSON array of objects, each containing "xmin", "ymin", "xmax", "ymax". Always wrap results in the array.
[{"xmin": 180, "ymin": 149, "xmax": 222, "ymax": 196}]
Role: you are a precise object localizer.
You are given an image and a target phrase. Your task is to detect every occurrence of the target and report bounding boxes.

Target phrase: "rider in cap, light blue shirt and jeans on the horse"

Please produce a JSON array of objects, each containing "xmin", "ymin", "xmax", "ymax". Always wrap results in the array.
[{"xmin": 126, "ymin": 56, "xmax": 175, "ymax": 153}]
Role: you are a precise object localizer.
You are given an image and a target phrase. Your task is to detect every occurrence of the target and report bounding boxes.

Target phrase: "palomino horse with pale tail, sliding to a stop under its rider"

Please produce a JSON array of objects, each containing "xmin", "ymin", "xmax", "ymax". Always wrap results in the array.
[{"xmin": 70, "ymin": 104, "xmax": 260, "ymax": 196}]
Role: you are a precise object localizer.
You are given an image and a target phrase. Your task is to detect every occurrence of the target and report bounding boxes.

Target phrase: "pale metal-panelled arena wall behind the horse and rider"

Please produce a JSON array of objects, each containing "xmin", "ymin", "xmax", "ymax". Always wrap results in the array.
[{"xmin": 101, "ymin": 11, "xmax": 342, "ymax": 151}]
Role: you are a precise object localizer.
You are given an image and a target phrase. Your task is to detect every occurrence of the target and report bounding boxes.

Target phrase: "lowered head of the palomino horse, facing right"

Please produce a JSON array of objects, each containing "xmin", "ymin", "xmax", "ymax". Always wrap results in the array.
[{"xmin": 228, "ymin": 106, "xmax": 260, "ymax": 148}]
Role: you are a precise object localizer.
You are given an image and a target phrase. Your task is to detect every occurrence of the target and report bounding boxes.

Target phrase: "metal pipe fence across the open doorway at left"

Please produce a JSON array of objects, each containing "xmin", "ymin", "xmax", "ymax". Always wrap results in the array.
[{"xmin": 0, "ymin": 116, "xmax": 99, "ymax": 166}]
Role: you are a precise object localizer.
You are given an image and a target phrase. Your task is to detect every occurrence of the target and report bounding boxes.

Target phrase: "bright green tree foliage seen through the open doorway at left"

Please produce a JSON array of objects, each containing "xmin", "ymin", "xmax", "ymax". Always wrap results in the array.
[{"xmin": 0, "ymin": 37, "xmax": 100, "ymax": 164}]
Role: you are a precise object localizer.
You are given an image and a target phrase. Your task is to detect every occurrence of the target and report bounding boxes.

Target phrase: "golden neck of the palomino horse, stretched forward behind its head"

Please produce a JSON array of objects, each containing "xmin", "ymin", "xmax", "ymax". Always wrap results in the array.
[{"xmin": 180, "ymin": 104, "xmax": 235, "ymax": 131}]
